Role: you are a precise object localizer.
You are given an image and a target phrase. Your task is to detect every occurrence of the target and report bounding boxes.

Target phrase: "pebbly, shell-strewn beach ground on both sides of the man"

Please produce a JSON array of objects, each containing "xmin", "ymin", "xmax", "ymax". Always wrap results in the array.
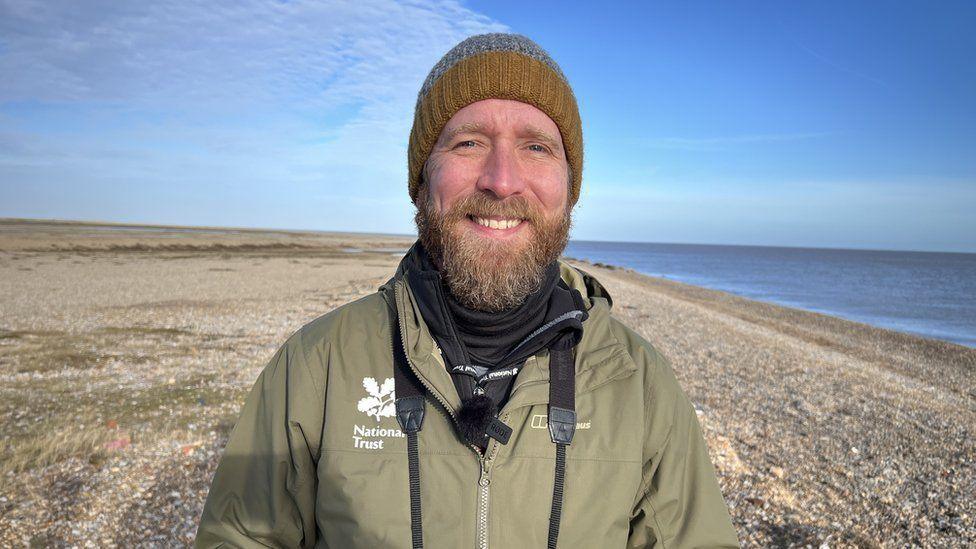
[{"xmin": 0, "ymin": 220, "xmax": 976, "ymax": 547}]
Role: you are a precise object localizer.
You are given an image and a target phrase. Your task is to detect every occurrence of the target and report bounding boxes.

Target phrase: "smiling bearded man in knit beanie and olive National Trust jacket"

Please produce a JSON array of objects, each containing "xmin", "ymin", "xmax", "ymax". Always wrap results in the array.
[{"xmin": 197, "ymin": 34, "xmax": 737, "ymax": 548}]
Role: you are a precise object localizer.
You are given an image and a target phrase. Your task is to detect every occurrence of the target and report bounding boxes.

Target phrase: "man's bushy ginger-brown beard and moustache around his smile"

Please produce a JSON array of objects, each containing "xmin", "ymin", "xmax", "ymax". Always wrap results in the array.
[{"xmin": 414, "ymin": 182, "xmax": 572, "ymax": 312}]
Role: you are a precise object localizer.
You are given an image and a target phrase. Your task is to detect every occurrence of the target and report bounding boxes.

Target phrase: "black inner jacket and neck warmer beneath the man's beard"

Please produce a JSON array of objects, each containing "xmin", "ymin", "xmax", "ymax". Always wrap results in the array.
[{"xmin": 407, "ymin": 240, "xmax": 588, "ymax": 409}]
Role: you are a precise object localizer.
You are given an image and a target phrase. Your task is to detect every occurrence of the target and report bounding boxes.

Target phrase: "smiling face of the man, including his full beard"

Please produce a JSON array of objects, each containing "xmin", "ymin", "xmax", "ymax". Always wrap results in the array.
[{"xmin": 415, "ymin": 99, "xmax": 572, "ymax": 311}]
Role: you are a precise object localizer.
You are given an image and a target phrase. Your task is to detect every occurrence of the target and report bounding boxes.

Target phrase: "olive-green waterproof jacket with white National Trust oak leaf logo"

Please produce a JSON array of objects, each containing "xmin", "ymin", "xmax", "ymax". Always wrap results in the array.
[{"xmin": 196, "ymin": 248, "xmax": 737, "ymax": 549}]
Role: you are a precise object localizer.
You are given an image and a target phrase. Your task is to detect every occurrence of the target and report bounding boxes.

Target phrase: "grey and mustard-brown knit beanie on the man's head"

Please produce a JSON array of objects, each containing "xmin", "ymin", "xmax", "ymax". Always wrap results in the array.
[{"xmin": 407, "ymin": 33, "xmax": 583, "ymax": 207}]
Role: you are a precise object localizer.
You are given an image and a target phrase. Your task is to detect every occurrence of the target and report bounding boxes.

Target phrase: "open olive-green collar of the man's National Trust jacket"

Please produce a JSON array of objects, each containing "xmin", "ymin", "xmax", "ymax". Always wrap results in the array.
[{"xmin": 381, "ymin": 243, "xmax": 637, "ymax": 415}]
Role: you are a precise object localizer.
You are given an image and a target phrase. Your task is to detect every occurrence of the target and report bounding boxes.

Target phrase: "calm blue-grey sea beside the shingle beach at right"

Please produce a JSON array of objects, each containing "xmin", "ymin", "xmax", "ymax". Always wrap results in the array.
[{"xmin": 564, "ymin": 240, "xmax": 976, "ymax": 347}]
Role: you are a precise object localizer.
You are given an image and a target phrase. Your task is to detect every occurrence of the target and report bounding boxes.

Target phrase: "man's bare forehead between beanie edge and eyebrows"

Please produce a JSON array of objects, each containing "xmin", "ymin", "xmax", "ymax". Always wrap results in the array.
[{"xmin": 441, "ymin": 98, "xmax": 561, "ymax": 139}]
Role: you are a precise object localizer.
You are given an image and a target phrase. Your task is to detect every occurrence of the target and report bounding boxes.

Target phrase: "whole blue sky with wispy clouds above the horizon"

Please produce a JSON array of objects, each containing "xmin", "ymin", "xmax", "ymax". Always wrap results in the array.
[{"xmin": 0, "ymin": 0, "xmax": 976, "ymax": 251}]
